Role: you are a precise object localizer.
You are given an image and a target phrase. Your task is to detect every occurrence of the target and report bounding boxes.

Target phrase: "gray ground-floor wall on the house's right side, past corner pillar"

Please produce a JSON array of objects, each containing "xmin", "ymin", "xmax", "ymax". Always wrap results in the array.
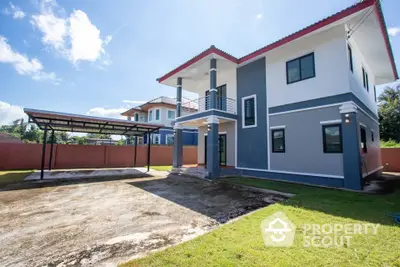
[{"xmin": 357, "ymin": 110, "xmax": 382, "ymax": 174}]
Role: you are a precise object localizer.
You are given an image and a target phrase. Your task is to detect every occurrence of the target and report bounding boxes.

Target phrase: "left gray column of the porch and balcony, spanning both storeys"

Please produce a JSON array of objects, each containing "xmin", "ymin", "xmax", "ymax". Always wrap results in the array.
[{"xmin": 172, "ymin": 77, "xmax": 183, "ymax": 168}]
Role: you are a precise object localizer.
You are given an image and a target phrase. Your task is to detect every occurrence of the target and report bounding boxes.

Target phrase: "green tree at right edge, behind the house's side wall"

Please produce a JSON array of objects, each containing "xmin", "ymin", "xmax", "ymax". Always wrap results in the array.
[{"xmin": 378, "ymin": 84, "xmax": 400, "ymax": 142}]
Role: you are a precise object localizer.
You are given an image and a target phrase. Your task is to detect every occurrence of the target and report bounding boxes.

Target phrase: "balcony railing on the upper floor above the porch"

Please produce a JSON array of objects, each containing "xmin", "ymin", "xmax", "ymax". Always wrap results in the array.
[{"xmin": 182, "ymin": 96, "xmax": 236, "ymax": 115}]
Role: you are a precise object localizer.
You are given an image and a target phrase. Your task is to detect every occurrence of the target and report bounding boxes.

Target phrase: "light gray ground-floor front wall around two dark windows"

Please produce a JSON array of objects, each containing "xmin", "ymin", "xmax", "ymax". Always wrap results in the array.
[{"xmin": 269, "ymin": 107, "xmax": 343, "ymax": 176}]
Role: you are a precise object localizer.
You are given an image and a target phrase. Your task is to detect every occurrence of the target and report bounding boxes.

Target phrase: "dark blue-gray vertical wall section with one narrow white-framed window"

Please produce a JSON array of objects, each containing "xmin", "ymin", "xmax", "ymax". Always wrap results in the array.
[{"xmin": 236, "ymin": 58, "xmax": 268, "ymax": 169}]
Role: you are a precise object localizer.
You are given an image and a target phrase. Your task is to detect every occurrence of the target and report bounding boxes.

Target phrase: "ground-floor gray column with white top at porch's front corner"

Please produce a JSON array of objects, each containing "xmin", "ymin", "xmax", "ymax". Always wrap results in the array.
[{"xmin": 205, "ymin": 116, "xmax": 220, "ymax": 179}]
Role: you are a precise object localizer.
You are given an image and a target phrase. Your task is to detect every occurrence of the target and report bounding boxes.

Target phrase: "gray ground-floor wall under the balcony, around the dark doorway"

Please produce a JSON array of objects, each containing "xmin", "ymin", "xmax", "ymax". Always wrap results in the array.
[{"xmin": 197, "ymin": 122, "xmax": 236, "ymax": 166}]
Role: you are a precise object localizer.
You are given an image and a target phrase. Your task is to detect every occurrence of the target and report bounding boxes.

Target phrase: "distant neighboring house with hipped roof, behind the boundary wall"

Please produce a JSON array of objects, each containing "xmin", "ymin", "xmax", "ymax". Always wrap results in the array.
[{"xmin": 121, "ymin": 96, "xmax": 197, "ymax": 146}]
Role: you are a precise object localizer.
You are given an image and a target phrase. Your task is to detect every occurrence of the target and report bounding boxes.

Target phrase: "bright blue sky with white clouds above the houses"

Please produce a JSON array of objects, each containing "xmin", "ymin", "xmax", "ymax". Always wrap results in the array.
[{"xmin": 0, "ymin": 0, "xmax": 400, "ymax": 125}]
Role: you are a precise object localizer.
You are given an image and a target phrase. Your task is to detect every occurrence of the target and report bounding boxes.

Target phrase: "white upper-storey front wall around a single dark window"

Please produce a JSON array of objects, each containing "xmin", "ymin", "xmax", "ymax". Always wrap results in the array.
[{"xmin": 266, "ymin": 25, "xmax": 350, "ymax": 107}]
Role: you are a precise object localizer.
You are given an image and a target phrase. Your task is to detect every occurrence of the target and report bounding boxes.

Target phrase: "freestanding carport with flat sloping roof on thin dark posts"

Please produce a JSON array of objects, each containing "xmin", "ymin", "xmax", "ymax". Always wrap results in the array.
[{"xmin": 24, "ymin": 108, "xmax": 163, "ymax": 179}]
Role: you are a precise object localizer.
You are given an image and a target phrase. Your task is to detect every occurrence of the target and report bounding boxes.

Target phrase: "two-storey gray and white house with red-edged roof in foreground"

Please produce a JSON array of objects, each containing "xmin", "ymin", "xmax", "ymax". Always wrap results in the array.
[{"xmin": 157, "ymin": 0, "xmax": 398, "ymax": 190}]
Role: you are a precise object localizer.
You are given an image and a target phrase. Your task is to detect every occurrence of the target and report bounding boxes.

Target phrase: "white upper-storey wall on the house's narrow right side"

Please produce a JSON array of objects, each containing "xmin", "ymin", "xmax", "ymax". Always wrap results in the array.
[{"xmin": 347, "ymin": 38, "xmax": 377, "ymax": 114}]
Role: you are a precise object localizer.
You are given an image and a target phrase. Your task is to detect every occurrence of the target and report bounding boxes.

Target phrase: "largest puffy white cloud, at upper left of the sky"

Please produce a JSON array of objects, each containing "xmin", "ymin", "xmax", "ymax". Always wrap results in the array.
[{"xmin": 31, "ymin": 0, "xmax": 112, "ymax": 65}]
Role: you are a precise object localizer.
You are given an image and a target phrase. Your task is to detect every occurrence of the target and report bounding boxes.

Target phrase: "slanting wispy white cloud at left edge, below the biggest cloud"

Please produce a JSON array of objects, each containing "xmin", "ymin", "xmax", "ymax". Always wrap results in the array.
[{"xmin": 0, "ymin": 35, "xmax": 59, "ymax": 83}]
